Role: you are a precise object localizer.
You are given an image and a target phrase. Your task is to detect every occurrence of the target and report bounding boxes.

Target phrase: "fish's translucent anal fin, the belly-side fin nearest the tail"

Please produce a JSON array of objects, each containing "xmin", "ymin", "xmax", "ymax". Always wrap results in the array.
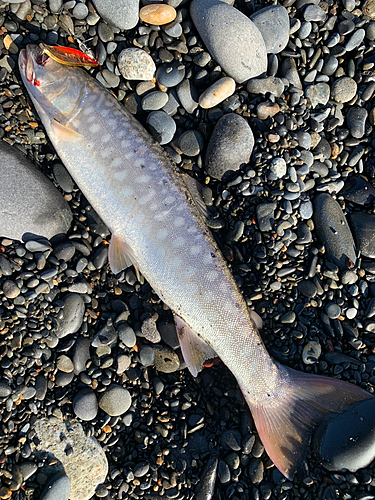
[{"xmin": 174, "ymin": 316, "xmax": 217, "ymax": 377}]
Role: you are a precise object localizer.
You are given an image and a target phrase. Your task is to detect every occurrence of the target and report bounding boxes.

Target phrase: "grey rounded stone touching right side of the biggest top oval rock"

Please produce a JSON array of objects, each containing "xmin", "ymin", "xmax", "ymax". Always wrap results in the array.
[{"xmin": 250, "ymin": 5, "xmax": 290, "ymax": 54}]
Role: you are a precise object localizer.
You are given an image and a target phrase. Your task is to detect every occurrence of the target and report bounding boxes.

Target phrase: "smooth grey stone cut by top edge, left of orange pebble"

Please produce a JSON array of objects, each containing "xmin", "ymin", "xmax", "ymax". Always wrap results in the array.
[{"xmin": 93, "ymin": 0, "xmax": 139, "ymax": 30}]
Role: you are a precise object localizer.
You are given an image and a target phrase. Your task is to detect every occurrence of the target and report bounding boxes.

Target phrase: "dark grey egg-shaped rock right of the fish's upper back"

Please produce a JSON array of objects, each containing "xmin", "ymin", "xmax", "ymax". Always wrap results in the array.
[{"xmin": 205, "ymin": 113, "xmax": 254, "ymax": 180}]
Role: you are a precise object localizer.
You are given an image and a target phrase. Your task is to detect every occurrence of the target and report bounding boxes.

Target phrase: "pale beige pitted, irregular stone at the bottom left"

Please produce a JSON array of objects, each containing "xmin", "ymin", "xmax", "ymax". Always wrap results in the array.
[{"xmin": 34, "ymin": 417, "xmax": 108, "ymax": 500}]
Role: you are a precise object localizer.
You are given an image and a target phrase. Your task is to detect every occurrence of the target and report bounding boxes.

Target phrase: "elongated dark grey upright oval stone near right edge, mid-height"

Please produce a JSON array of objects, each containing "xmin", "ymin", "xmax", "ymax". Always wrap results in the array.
[{"xmin": 313, "ymin": 193, "xmax": 357, "ymax": 270}]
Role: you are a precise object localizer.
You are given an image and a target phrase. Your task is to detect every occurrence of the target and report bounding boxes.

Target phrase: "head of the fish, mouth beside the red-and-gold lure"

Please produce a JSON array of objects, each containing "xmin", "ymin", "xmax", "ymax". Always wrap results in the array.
[{"xmin": 18, "ymin": 44, "xmax": 83, "ymax": 121}]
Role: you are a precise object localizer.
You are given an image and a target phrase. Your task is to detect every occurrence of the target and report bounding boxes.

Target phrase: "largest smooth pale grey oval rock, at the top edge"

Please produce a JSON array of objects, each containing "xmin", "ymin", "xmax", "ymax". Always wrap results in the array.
[{"xmin": 190, "ymin": 0, "xmax": 267, "ymax": 83}]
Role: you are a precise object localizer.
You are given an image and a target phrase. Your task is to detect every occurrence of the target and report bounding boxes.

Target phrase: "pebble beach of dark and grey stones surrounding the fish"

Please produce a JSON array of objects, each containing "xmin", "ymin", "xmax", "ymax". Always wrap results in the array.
[{"xmin": 0, "ymin": 0, "xmax": 375, "ymax": 500}]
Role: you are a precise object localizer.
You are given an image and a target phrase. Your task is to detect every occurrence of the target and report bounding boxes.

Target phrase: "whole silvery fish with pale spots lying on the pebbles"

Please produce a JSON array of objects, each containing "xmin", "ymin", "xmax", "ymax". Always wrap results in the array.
[{"xmin": 19, "ymin": 45, "xmax": 373, "ymax": 479}]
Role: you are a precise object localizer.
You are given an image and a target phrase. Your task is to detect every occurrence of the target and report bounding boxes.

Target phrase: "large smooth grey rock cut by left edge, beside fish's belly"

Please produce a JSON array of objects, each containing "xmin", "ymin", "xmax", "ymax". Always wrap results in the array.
[{"xmin": 0, "ymin": 141, "xmax": 73, "ymax": 241}]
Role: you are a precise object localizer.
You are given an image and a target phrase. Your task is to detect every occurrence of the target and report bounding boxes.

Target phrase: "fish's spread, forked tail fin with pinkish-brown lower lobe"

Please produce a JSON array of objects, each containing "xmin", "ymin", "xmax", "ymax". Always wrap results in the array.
[{"xmin": 242, "ymin": 365, "xmax": 372, "ymax": 479}]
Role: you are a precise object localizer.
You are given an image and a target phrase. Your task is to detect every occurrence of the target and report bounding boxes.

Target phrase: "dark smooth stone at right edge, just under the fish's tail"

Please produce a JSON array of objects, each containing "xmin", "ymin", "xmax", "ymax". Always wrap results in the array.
[{"xmin": 313, "ymin": 398, "xmax": 375, "ymax": 472}]
